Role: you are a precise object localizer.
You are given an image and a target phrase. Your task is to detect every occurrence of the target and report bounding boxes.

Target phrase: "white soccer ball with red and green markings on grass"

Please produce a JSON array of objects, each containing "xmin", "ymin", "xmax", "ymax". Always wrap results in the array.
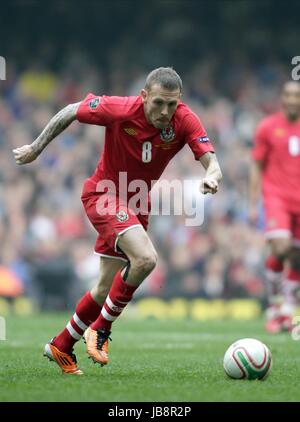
[{"xmin": 223, "ymin": 338, "xmax": 272, "ymax": 380}]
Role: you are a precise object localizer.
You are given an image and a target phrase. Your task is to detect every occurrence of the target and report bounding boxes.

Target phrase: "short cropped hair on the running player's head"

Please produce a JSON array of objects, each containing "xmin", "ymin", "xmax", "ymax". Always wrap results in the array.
[{"xmin": 145, "ymin": 67, "xmax": 182, "ymax": 92}]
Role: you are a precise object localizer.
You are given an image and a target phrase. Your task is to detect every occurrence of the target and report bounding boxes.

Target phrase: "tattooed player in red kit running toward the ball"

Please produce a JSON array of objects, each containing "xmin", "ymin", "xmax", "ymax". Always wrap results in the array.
[{"xmin": 14, "ymin": 68, "xmax": 222, "ymax": 374}]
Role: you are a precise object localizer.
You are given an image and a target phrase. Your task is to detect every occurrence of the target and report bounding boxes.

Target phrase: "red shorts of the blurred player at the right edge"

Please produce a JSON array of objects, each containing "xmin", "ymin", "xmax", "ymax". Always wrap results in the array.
[{"xmin": 264, "ymin": 196, "xmax": 300, "ymax": 246}]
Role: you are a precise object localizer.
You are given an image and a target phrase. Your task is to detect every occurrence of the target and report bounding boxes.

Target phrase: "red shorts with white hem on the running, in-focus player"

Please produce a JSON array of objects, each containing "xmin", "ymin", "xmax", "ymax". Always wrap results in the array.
[{"xmin": 81, "ymin": 192, "xmax": 149, "ymax": 261}]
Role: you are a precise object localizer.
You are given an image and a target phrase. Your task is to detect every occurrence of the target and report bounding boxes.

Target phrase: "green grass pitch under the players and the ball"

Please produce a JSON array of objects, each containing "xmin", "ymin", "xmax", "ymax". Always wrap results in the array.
[{"xmin": 0, "ymin": 314, "xmax": 300, "ymax": 402}]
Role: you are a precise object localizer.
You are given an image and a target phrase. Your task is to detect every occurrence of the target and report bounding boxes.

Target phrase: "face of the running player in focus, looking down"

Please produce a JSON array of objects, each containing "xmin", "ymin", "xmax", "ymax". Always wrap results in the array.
[{"xmin": 141, "ymin": 85, "xmax": 181, "ymax": 129}]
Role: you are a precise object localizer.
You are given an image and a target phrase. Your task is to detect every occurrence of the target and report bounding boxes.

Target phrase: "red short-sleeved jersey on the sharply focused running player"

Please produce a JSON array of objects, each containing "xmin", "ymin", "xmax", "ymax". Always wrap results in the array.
[{"xmin": 77, "ymin": 94, "xmax": 214, "ymax": 197}]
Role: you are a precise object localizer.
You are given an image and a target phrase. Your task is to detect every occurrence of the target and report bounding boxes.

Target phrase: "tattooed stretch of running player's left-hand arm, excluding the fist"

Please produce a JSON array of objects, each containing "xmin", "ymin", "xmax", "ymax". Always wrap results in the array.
[{"xmin": 32, "ymin": 103, "xmax": 80, "ymax": 153}]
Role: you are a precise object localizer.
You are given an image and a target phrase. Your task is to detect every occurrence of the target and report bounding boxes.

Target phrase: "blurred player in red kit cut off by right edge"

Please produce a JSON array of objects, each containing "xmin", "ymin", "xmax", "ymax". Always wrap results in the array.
[{"xmin": 250, "ymin": 81, "xmax": 300, "ymax": 333}]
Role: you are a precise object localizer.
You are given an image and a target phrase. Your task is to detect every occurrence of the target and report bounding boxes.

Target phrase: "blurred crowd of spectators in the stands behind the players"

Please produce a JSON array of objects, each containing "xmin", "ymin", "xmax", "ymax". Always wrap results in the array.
[{"xmin": 0, "ymin": 54, "xmax": 289, "ymax": 309}]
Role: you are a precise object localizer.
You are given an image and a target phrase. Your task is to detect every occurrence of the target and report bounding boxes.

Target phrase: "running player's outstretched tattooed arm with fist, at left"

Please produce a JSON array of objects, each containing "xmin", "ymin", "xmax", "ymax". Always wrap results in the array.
[{"xmin": 13, "ymin": 102, "xmax": 80, "ymax": 164}]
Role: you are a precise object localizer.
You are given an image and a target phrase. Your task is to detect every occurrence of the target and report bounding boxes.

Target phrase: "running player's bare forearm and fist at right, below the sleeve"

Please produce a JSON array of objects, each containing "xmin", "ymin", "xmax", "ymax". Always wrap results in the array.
[{"xmin": 199, "ymin": 152, "xmax": 222, "ymax": 194}]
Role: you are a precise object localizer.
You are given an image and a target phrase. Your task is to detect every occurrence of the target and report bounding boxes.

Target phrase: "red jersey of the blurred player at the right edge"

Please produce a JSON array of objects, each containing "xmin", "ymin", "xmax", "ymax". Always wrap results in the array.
[{"xmin": 252, "ymin": 112, "xmax": 300, "ymax": 212}]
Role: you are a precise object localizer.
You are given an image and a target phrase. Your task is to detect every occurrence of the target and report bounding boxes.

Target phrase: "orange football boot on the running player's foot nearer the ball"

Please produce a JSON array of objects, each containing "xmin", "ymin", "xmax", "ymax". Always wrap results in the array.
[{"xmin": 83, "ymin": 327, "xmax": 111, "ymax": 366}]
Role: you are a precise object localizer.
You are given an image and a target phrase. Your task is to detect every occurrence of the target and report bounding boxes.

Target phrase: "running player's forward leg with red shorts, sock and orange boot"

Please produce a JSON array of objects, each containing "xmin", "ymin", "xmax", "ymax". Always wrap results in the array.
[{"xmin": 83, "ymin": 194, "xmax": 156, "ymax": 364}]
